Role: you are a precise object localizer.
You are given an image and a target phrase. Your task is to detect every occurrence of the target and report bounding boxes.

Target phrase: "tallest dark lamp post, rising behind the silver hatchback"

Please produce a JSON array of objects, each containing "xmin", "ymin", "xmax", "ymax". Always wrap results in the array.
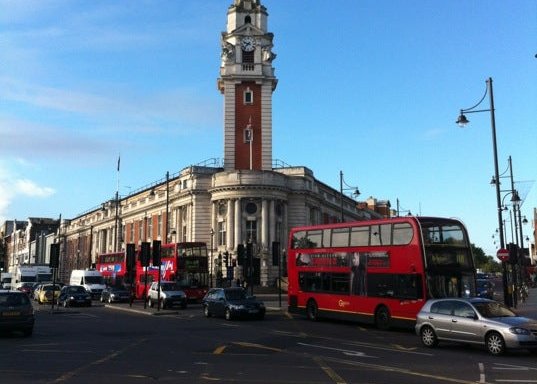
[{"xmin": 457, "ymin": 77, "xmax": 510, "ymax": 304}]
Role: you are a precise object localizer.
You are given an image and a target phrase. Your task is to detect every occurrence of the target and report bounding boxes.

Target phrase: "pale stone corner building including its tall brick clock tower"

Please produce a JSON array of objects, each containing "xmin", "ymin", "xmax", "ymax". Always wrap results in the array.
[{"xmin": 61, "ymin": 0, "xmax": 389, "ymax": 286}]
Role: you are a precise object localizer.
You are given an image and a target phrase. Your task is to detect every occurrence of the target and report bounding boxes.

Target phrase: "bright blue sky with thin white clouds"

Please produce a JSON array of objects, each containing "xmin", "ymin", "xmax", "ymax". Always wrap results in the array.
[{"xmin": 0, "ymin": 0, "xmax": 537, "ymax": 254}]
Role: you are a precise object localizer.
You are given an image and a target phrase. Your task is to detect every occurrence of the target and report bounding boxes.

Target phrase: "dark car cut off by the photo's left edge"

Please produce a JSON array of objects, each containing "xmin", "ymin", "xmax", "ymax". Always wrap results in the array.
[{"xmin": 0, "ymin": 291, "xmax": 35, "ymax": 336}]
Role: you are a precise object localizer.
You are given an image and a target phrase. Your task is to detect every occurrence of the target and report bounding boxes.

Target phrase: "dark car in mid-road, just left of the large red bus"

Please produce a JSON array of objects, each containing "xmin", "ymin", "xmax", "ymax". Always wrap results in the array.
[{"xmin": 202, "ymin": 287, "xmax": 266, "ymax": 320}]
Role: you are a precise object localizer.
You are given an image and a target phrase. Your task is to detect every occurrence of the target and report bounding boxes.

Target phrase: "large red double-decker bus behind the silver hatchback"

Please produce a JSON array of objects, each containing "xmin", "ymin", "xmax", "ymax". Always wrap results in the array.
[{"xmin": 287, "ymin": 216, "xmax": 475, "ymax": 329}]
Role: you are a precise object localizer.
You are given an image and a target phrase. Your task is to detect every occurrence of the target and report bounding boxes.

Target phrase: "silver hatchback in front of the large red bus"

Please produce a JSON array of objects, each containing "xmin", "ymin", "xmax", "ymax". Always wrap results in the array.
[{"xmin": 416, "ymin": 297, "xmax": 537, "ymax": 355}]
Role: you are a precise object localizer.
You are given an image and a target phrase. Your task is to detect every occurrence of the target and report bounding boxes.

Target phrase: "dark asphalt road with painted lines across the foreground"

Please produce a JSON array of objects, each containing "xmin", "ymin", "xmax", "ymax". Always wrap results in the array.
[{"xmin": 0, "ymin": 302, "xmax": 537, "ymax": 384}]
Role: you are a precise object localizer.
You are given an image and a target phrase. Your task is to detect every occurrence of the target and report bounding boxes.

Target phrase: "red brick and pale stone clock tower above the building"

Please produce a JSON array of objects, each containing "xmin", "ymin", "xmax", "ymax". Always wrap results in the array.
[{"xmin": 218, "ymin": 0, "xmax": 278, "ymax": 171}]
